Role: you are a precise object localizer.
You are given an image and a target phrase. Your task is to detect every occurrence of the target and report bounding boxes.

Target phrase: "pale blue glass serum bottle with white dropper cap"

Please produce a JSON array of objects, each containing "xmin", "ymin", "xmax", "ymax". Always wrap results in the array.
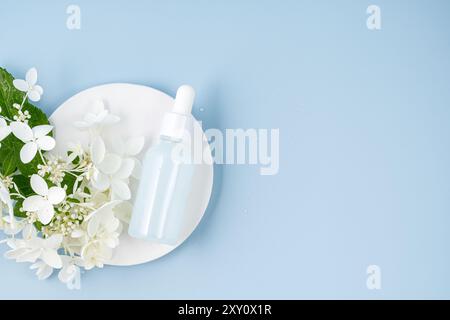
[{"xmin": 128, "ymin": 85, "xmax": 195, "ymax": 245}]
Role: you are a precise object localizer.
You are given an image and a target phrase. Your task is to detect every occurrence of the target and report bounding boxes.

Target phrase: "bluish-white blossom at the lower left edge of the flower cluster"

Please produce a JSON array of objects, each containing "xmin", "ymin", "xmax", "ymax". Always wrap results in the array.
[{"xmin": 5, "ymin": 224, "xmax": 63, "ymax": 277}]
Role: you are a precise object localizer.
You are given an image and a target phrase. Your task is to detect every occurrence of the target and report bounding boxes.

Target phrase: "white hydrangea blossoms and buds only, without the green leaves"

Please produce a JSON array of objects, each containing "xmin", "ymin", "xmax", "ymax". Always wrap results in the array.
[{"xmin": 0, "ymin": 82, "xmax": 149, "ymax": 289}]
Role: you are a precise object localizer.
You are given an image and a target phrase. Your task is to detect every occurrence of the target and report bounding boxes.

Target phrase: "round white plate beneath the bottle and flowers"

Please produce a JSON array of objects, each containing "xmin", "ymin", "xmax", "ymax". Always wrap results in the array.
[{"xmin": 50, "ymin": 83, "xmax": 213, "ymax": 266}]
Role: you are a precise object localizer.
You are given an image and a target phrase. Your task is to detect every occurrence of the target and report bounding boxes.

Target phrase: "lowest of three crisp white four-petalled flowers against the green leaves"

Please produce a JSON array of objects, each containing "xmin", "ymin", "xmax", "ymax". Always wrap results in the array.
[{"xmin": 22, "ymin": 174, "xmax": 66, "ymax": 225}]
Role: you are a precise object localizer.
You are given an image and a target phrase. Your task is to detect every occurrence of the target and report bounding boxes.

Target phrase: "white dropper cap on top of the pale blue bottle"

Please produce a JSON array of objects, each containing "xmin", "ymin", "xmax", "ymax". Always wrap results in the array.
[{"xmin": 160, "ymin": 85, "xmax": 195, "ymax": 140}]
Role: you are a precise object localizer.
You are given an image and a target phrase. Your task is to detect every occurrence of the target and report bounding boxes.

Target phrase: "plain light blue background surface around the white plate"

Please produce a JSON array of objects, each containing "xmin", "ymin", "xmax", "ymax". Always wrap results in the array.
[{"xmin": 0, "ymin": 0, "xmax": 450, "ymax": 299}]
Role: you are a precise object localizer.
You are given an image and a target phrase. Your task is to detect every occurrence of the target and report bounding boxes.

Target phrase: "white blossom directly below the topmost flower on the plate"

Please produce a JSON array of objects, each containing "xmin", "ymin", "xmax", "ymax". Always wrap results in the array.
[{"xmin": 91, "ymin": 136, "xmax": 135, "ymax": 200}]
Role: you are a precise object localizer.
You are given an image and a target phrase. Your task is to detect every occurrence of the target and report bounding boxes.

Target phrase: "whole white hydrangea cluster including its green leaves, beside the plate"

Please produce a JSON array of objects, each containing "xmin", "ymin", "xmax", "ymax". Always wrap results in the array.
[{"xmin": 0, "ymin": 68, "xmax": 144, "ymax": 289}]
